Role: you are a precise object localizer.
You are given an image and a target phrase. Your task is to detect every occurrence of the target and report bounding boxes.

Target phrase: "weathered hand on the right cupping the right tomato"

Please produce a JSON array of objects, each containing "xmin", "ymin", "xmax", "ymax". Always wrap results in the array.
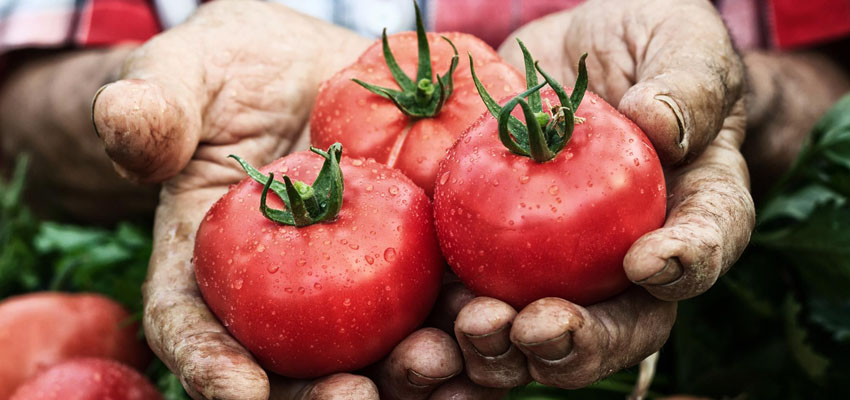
[{"xmin": 455, "ymin": 0, "xmax": 754, "ymax": 388}]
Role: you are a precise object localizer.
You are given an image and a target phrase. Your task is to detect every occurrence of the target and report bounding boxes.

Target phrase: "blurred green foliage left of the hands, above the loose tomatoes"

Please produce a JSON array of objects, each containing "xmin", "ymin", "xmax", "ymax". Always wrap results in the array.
[{"xmin": 0, "ymin": 156, "xmax": 189, "ymax": 400}]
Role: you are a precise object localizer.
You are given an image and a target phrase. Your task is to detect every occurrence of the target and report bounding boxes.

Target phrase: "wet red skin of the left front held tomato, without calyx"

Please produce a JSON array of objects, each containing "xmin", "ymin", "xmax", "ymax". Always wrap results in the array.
[{"xmin": 194, "ymin": 152, "xmax": 445, "ymax": 378}]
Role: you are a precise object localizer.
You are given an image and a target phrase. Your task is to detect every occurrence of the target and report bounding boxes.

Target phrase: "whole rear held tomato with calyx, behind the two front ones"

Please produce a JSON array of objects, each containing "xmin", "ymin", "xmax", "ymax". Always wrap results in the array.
[{"xmin": 310, "ymin": 2, "xmax": 523, "ymax": 196}]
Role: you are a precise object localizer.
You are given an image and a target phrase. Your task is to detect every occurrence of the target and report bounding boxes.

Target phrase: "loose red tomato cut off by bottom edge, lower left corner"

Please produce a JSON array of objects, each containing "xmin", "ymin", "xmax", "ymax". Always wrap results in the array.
[{"xmin": 11, "ymin": 358, "xmax": 162, "ymax": 400}]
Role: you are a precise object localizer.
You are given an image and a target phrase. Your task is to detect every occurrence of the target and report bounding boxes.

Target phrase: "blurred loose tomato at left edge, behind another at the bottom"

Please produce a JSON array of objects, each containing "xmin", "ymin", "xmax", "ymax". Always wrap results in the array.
[{"xmin": 0, "ymin": 292, "xmax": 150, "ymax": 399}]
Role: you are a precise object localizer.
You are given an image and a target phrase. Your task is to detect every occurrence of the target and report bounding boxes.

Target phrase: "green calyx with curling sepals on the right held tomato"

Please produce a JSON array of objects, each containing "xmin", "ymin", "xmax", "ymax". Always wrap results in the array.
[{"xmin": 469, "ymin": 39, "xmax": 588, "ymax": 163}]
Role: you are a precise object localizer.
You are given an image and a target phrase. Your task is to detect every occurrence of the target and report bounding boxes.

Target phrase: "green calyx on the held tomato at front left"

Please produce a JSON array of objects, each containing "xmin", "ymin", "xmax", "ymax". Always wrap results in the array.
[{"xmin": 229, "ymin": 143, "xmax": 344, "ymax": 227}]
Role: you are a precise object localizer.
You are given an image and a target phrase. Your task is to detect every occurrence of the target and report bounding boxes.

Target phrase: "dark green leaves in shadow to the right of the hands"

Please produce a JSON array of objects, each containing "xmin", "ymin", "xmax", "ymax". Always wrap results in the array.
[{"xmin": 656, "ymin": 96, "xmax": 850, "ymax": 399}]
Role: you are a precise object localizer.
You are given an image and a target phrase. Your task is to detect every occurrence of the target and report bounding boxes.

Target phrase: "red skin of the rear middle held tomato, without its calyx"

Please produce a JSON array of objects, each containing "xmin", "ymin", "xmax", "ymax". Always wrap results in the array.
[{"xmin": 310, "ymin": 32, "xmax": 525, "ymax": 196}]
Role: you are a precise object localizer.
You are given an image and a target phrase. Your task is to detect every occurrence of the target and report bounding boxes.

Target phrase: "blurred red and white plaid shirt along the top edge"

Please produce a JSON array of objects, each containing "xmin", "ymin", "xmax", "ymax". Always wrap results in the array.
[{"xmin": 0, "ymin": 0, "xmax": 850, "ymax": 55}]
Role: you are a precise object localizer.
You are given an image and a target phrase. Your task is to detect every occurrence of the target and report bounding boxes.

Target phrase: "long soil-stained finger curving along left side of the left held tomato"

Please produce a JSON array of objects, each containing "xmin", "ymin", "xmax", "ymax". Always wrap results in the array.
[{"xmin": 142, "ymin": 189, "xmax": 269, "ymax": 400}]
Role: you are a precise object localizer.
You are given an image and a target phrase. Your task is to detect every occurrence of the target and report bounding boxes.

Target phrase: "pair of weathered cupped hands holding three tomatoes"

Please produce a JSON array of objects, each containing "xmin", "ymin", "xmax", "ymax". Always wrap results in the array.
[{"xmin": 93, "ymin": 0, "xmax": 754, "ymax": 400}]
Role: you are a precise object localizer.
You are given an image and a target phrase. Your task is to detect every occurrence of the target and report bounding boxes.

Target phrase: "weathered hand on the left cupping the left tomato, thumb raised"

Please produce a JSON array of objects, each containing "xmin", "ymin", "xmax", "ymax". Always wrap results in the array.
[{"xmin": 93, "ymin": 1, "xmax": 463, "ymax": 400}]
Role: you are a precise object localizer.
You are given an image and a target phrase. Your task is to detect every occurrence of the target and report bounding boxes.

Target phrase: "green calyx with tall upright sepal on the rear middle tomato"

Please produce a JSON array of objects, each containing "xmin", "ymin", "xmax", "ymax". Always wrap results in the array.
[{"xmin": 352, "ymin": 2, "xmax": 458, "ymax": 119}]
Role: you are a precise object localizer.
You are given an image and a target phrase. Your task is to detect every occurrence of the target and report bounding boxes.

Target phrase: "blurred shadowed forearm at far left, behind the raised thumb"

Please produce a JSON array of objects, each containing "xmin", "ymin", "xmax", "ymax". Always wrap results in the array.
[{"xmin": 0, "ymin": 47, "xmax": 158, "ymax": 224}]
